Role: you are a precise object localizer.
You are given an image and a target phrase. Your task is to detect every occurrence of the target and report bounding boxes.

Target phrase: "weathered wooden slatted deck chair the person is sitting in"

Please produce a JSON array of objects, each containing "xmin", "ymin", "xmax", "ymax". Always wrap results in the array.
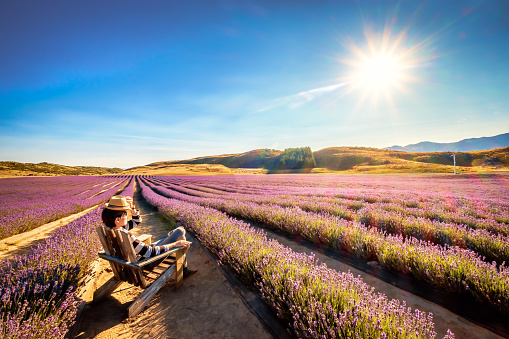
[{"xmin": 93, "ymin": 226, "xmax": 187, "ymax": 318}]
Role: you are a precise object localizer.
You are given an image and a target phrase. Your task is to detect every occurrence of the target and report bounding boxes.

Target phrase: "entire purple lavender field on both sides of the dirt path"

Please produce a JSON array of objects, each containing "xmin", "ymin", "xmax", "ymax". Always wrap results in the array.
[{"xmin": 0, "ymin": 174, "xmax": 509, "ymax": 338}]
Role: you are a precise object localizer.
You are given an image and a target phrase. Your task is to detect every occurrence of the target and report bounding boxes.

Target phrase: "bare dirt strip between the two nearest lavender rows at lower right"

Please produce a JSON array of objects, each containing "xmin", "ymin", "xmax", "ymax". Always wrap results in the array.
[{"xmin": 251, "ymin": 223, "xmax": 503, "ymax": 339}]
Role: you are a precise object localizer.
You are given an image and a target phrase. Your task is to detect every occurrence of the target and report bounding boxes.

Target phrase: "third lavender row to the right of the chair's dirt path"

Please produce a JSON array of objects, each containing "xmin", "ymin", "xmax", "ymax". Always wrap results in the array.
[{"xmin": 142, "ymin": 179, "xmax": 509, "ymax": 264}]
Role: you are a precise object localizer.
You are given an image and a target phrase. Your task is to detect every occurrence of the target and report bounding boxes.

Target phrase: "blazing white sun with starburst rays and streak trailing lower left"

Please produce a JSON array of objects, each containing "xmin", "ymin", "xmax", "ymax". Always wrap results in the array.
[{"xmin": 254, "ymin": 24, "xmax": 435, "ymax": 118}]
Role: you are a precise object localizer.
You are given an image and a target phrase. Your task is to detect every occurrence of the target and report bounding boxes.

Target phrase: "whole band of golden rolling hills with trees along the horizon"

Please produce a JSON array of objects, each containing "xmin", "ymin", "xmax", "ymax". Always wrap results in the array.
[{"xmin": 0, "ymin": 147, "xmax": 509, "ymax": 176}]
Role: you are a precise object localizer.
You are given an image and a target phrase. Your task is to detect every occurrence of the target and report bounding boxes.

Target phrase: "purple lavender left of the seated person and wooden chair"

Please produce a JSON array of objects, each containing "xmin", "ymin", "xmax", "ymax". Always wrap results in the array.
[{"xmin": 0, "ymin": 177, "xmax": 135, "ymax": 338}]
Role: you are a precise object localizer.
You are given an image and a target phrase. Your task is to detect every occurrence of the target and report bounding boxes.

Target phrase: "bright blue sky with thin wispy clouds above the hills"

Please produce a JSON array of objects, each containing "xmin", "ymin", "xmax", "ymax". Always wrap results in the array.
[{"xmin": 0, "ymin": 0, "xmax": 509, "ymax": 168}]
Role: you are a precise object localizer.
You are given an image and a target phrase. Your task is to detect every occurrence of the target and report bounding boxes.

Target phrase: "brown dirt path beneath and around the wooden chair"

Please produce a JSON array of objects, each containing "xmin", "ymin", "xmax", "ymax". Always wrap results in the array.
[{"xmin": 75, "ymin": 186, "xmax": 272, "ymax": 339}]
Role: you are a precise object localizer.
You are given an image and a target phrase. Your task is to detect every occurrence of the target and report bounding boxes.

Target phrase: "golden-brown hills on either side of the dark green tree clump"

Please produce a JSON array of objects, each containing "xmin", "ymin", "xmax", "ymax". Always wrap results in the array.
[{"xmin": 129, "ymin": 147, "xmax": 509, "ymax": 173}]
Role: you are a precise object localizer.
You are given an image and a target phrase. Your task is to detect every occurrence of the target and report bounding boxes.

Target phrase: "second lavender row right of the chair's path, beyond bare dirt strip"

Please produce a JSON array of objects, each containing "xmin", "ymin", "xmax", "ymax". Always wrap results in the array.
[{"xmin": 140, "ymin": 178, "xmax": 509, "ymax": 313}]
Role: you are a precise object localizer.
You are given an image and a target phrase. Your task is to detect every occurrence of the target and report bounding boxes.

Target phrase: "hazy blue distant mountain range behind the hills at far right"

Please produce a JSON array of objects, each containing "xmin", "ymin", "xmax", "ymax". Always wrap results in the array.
[{"xmin": 385, "ymin": 133, "xmax": 509, "ymax": 153}]
